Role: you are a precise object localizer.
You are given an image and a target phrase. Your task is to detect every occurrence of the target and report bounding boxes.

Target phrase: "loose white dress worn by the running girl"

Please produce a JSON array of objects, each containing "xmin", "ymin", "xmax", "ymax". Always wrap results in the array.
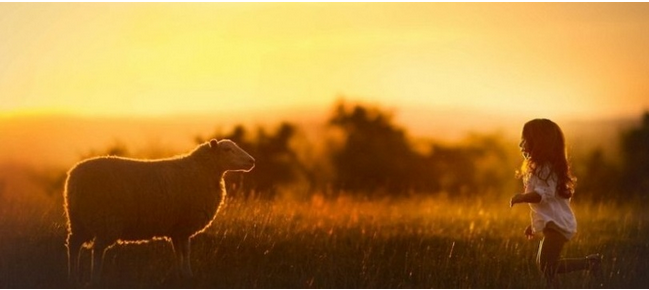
[{"xmin": 524, "ymin": 165, "xmax": 577, "ymax": 240}]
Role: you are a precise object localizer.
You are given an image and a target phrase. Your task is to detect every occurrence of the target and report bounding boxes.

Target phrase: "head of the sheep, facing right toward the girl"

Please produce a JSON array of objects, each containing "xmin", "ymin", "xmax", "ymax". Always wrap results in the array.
[{"xmin": 209, "ymin": 139, "xmax": 255, "ymax": 172}]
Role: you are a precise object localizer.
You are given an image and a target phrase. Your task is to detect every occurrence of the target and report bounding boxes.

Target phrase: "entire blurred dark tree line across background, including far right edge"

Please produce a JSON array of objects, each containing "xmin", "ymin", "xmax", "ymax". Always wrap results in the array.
[{"xmin": 39, "ymin": 101, "xmax": 649, "ymax": 201}]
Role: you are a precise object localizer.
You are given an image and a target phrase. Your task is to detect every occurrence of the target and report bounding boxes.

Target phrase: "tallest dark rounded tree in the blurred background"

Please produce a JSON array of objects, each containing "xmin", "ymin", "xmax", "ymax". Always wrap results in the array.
[{"xmin": 329, "ymin": 103, "xmax": 418, "ymax": 193}]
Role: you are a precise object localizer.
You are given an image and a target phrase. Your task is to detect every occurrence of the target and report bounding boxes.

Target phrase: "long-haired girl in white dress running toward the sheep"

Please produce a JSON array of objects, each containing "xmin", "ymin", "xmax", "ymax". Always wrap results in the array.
[{"xmin": 510, "ymin": 119, "xmax": 602, "ymax": 287}]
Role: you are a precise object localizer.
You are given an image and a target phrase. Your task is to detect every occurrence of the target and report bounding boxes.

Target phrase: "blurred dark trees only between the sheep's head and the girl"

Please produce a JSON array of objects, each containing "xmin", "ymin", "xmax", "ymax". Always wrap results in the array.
[{"xmin": 196, "ymin": 102, "xmax": 515, "ymax": 197}]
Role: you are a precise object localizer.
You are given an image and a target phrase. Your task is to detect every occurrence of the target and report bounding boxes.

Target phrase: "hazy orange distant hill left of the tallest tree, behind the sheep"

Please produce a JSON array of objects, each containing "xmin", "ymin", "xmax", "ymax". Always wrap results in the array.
[{"xmin": 0, "ymin": 107, "xmax": 322, "ymax": 167}]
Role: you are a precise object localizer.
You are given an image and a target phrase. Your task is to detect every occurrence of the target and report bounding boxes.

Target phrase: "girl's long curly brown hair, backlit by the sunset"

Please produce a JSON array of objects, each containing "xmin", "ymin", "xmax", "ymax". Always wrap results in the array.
[{"xmin": 519, "ymin": 119, "xmax": 576, "ymax": 198}]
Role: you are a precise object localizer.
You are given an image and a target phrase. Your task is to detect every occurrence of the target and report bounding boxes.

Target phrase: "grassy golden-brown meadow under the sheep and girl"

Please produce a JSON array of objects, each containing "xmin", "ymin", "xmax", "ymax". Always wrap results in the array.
[{"xmin": 0, "ymin": 167, "xmax": 649, "ymax": 288}]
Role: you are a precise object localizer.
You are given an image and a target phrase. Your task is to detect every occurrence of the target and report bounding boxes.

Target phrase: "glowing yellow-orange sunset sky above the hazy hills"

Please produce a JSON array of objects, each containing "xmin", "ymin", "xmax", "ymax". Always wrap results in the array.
[{"xmin": 0, "ymin": 3, "xmax": 649, "ymax": 119}]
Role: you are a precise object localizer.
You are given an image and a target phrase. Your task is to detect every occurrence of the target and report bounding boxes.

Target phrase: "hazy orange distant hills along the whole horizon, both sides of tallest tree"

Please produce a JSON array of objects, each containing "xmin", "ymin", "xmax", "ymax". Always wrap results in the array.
[{"xmin": 0, "ymin": 108, "xmax": 639, "ymax": 167}]
